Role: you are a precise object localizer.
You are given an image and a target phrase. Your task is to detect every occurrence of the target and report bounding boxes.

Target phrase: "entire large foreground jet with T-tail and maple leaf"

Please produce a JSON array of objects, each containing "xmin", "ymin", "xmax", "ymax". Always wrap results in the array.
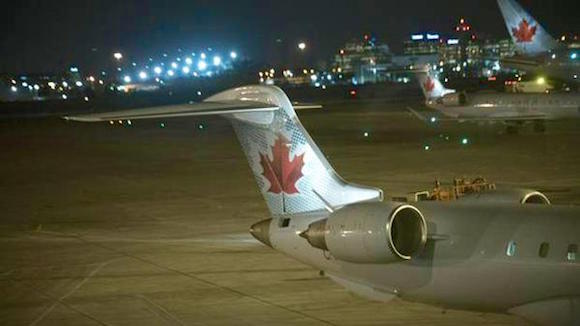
[{"xmin": 65, "ymin": 85, "xmax": 580, "ymax": 325}]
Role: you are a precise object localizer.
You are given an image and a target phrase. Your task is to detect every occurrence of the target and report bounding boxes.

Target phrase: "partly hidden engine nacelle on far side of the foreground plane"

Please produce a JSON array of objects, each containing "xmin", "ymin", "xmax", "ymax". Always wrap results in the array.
[{"xmin": 461, "ymin": 189, "xmax": 551, "ymax": 205}]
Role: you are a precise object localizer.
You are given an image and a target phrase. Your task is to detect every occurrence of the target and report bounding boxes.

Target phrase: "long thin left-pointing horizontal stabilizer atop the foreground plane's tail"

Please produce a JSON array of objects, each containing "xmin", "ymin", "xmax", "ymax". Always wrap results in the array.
[{"xmin": 63, "ymin": 100, "xmax": 278, "ymax": 122}]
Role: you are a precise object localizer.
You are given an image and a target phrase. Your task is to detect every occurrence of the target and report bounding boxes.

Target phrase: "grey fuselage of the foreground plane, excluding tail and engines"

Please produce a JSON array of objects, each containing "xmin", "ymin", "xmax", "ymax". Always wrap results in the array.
[{"xmin": 270, "ymin": 202, "xmax": 580, "ymax": 311}]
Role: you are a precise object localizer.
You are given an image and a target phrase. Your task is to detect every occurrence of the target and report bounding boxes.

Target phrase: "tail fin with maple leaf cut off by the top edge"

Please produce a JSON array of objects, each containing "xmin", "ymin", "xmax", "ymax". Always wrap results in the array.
[{"xmin": 497, "ymin": 0, "xmax": 558, "ymax": 55}]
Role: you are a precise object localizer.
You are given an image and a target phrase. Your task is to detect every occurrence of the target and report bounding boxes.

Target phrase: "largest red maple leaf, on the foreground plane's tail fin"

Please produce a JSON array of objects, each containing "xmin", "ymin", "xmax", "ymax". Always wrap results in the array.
[{"xmin": 260, "ymin": 135, "xmax": 304, "ymax": 195}]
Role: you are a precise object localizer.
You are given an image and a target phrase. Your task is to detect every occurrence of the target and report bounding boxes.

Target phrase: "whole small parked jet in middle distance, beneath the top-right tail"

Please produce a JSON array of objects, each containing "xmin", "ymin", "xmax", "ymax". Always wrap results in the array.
[{"xmin": 409, "ymin": 67, "xmax": 580, "ymax": 133}]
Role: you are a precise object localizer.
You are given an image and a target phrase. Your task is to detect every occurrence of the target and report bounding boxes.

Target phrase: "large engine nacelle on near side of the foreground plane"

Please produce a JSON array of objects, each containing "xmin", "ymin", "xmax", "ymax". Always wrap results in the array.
[{"xmin": 300, "ymin": 203, "xmax": 427, "ymax": 263}]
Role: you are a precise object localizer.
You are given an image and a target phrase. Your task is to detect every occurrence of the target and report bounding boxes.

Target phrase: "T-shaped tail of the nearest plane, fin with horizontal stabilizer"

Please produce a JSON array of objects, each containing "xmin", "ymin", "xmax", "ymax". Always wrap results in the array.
[{"xmin": 65, "ymin": 86, "xmax": 383, "ymax": 216}]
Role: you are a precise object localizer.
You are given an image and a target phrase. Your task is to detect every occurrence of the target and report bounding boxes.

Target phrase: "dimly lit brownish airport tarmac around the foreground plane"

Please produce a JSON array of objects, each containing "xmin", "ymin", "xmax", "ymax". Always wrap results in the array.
[{"xmin": 0, "ymin": 93, "xmax": 580, "ymax": 325}]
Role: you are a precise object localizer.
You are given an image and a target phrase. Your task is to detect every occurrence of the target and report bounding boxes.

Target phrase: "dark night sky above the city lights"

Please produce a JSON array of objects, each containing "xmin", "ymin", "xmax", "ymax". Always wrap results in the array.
[{"xmin": 0, "ymin": 0, "xmax": 580, "ymax": 73}]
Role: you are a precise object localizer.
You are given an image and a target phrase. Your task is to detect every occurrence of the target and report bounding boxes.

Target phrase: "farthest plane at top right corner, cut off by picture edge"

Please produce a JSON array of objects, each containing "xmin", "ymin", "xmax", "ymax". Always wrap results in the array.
[{"xmin": 497, "ymin": 0, "xmax": 580, "ymax": 83}]
